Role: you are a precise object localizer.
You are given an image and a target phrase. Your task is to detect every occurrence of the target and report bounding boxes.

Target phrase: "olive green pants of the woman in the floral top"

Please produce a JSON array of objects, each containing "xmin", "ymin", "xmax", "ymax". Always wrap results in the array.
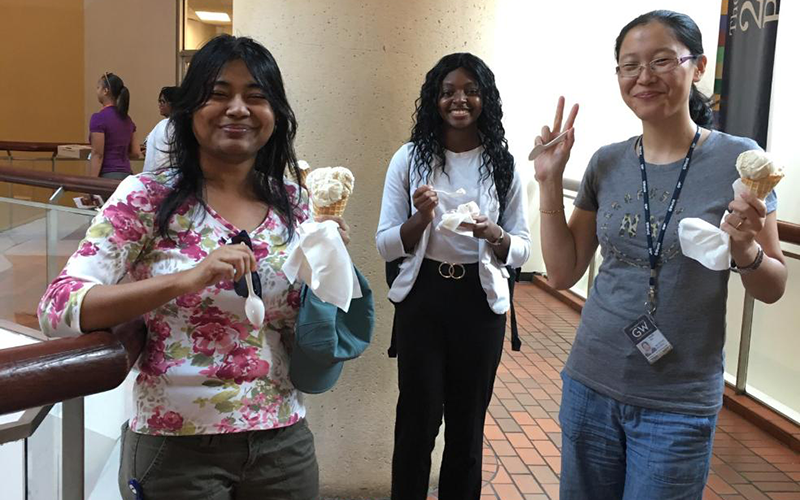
[{"xmin": 119, "ymin": 420, "xmax": 319, "ymax": 500}]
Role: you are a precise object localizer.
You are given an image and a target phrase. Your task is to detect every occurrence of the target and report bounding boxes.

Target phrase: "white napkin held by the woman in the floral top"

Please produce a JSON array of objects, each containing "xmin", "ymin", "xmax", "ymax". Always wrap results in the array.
[{"xmin": 283, "ymin": 220, "xmax": 363, "ymax": 312}]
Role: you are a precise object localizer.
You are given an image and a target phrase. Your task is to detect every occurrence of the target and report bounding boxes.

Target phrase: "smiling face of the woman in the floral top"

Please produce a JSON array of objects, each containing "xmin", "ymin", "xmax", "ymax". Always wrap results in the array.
[{"xmin": 192, "ymin": 60, "xmax": 275, "ymax": 162}]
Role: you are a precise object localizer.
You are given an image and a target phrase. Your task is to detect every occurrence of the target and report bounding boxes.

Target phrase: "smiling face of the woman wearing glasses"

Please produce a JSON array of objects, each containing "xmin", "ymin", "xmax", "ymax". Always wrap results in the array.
[{"xmin": 617, "ymin": 21, "xmax": 706, "ymax": 122}]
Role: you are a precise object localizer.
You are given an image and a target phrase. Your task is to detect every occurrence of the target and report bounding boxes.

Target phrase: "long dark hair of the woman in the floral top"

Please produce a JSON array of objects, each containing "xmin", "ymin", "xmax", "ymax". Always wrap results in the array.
[{"xmin": 156, "ymin": 35, "xmax": 300, "ymax": 241}]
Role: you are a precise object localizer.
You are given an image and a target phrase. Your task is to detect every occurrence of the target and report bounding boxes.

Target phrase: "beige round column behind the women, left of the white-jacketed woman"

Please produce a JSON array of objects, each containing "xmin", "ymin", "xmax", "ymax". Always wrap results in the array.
[{"xmin": 233, "ymin": 0, "xmax": 494, "ymax": 496}]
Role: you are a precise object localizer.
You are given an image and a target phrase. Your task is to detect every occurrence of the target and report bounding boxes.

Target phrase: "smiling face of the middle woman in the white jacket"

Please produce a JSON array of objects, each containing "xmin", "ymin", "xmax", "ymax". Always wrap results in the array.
[{"xmin": 438, "ymin": 68, "xmax": 483, "ymax": 130}]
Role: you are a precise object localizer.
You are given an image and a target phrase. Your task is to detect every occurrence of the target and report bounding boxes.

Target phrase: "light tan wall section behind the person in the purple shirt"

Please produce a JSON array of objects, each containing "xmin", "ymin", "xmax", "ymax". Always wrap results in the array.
[{"xmin": 83, "ymin": 0, "xmax": 178, "ymax": 141}]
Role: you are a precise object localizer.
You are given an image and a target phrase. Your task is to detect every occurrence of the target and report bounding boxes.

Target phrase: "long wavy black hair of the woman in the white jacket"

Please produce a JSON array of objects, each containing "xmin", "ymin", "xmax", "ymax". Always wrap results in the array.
[{"xmin": 410, "ymin": 53, "xmax": 514, "ymax": 220}]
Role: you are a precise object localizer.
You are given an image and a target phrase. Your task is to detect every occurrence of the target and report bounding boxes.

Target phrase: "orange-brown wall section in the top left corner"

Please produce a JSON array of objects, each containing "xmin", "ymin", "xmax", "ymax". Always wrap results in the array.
[{"xmin": 0, "ymin": 0, "xmax": 87, "ymax": 142}]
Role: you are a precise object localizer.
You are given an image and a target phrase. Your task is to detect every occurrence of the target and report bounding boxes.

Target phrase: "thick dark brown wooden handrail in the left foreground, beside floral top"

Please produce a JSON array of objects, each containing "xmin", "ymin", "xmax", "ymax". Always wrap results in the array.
[{"xmin": 0, "ymin": 318, "xmax": 147, "ymax": 415}]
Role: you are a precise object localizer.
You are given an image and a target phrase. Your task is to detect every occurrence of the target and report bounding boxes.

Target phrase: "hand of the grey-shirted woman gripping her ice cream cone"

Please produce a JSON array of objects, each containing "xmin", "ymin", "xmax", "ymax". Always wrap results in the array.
[{"xmin": 720, "ymin": 189, "xmax": 767, "ymax": 265}]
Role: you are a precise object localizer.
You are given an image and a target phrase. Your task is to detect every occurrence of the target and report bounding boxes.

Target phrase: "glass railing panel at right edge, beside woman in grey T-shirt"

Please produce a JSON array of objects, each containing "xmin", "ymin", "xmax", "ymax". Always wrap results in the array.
[{"xmin": 746, "ymin": 247, "xmax": 800, "ymax": 423}]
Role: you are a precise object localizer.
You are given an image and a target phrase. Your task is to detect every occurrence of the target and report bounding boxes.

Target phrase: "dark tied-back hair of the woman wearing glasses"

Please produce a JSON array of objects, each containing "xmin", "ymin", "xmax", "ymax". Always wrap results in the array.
[{"xmin": 614, "ymin": 10, "xmax": 714, "ymax": 128}]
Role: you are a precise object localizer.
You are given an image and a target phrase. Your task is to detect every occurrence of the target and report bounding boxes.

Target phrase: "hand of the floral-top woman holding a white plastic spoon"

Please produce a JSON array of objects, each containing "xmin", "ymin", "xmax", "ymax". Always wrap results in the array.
[{"xmin": 181, "ymin": 244, "xmax": 256, "ymax": 293}]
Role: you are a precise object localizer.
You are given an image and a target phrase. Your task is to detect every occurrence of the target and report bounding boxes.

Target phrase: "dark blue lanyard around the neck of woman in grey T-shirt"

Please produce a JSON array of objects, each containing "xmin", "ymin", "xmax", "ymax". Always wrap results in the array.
[{"xmin": 639, "ymin": 127, "xmax": 700, "ymax": 314}]
